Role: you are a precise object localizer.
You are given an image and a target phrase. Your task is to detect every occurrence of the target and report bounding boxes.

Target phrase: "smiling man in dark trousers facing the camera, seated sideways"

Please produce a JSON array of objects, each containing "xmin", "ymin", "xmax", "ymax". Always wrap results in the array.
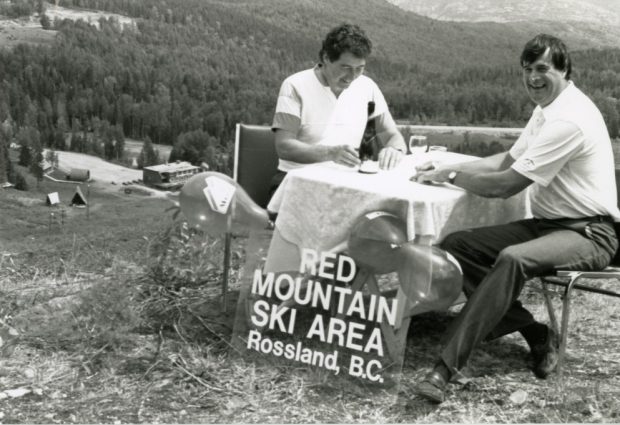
[{"xmin": 415, "ymin": 34, "xmax": 620, "ymax": 402}]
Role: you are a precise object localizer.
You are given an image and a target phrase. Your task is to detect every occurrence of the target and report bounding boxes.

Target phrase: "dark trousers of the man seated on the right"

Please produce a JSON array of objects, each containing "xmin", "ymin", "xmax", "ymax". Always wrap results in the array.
[{"xmin": 441, "ymin": 216, "xmax": 618, "ymax": 372}]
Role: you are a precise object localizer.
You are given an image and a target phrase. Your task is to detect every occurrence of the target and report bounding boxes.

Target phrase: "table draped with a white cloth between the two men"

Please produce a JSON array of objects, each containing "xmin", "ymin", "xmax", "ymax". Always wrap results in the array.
[{"xmin": 263, "ymin": 151, "xmax": 529, "ymax": 364}]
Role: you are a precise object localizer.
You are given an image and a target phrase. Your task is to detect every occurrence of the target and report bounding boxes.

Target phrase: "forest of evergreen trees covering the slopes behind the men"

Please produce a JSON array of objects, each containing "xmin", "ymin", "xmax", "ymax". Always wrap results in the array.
[{"xmin": 0, "ymin": 0, "xmax": 620, "ymax": 184}]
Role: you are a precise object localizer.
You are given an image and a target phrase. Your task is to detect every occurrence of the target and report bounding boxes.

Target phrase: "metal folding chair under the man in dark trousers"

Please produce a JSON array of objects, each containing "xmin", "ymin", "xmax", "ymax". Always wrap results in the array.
[{"xmin": 541, "ymin": 169, "xmax": 620, "ymax": 380}]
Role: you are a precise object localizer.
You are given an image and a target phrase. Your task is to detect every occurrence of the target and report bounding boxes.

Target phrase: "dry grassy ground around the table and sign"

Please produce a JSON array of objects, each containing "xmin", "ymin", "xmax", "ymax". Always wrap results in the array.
[{"xmin": 0, "ymin": 181, "xmax": 620, "ymax": 423}]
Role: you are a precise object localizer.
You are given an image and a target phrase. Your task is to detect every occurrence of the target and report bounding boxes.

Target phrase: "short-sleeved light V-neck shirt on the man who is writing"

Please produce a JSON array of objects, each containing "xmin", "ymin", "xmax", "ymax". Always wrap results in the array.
[{"xmin": 271, "ymin": 69, "xmax": 391, "ymax": 171}]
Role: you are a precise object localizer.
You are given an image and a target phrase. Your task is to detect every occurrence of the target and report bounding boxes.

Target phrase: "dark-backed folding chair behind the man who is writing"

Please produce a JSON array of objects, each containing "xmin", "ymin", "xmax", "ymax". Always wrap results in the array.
[{"xmin": 222, "ymin": 124, "xmax": 278, "ymax": 311}]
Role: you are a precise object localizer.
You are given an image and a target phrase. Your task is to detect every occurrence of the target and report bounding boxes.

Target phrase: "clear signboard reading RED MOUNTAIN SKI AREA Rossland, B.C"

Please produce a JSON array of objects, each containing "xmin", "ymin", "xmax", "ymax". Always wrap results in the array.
[{"xmin": 232, "ymin": 241, "xmax": 404, "ymax": 394}]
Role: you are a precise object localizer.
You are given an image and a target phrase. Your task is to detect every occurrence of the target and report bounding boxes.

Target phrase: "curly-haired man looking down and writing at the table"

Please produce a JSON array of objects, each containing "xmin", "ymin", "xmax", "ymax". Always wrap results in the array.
[{"xmin": 272, "ymin": 24, "xmax": 405, "ymax": 192}]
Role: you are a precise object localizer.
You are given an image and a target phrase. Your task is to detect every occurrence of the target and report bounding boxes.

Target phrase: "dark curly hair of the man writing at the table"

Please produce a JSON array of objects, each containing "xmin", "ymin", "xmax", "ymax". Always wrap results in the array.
[{"xmin": 319, "ymin": 23, "xmax": 372, "ymax": 63}]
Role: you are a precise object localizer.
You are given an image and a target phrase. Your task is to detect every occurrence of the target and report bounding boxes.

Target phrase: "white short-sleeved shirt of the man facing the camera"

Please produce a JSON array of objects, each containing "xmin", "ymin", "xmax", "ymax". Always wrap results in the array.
[{"xmin": 510, "ymin": 82, "xmax": 620, "ymax": 221}]
